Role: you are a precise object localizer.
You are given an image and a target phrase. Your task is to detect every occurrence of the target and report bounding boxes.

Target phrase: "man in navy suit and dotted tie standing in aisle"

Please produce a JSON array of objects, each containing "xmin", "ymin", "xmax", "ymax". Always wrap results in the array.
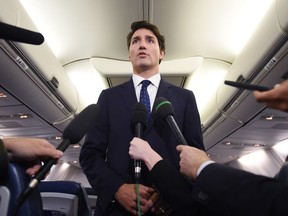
[{"xmin": 80, "ymin": 21, "xmax": 204, "ymax": 216}]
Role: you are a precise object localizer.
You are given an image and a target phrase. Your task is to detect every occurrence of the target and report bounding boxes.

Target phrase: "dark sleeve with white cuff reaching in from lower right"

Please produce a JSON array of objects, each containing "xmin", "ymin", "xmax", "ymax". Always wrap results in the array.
[{"xmin": 193, "ymin": 163, "xmax": 288, "ymax": 216}]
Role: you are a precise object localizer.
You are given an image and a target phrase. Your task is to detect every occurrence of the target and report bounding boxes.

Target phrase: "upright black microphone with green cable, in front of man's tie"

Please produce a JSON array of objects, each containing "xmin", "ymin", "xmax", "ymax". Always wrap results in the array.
[{"xmin": 131, "ymin": 102, "xmax": 147, "ymax": 179}]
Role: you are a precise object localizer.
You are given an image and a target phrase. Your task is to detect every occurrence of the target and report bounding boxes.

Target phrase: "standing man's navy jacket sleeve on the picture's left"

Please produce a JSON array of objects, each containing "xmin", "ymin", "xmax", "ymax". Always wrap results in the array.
[{"xmin": 80, "ymin": 91, "xmax": 124, "ymax": 211}]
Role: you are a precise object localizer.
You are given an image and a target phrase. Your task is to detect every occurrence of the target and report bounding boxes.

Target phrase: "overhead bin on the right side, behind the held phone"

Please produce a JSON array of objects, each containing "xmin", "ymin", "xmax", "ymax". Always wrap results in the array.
[{"xmin": 203, "ymin": 0, "xmax": 288, "ymax": 149}]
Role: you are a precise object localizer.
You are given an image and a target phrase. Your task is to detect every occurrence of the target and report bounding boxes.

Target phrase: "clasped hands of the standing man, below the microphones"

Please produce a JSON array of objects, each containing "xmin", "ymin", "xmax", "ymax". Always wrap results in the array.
[{"xmin": 115, "ymin": 184, "xmax": 154, "ymax": 216}]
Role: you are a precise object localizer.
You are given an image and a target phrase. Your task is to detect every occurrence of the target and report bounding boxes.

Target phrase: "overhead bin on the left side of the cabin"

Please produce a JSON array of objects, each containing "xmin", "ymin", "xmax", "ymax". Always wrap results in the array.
[{"xmin": 0, "ymin": 0, "xmax": 78, "ymax": 129}]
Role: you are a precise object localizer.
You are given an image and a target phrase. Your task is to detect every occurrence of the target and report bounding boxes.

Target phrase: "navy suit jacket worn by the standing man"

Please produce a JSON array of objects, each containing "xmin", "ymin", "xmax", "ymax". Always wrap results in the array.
[{"xmin": 80, "ymin": 79, "xmax": 204, "ymax": 215}]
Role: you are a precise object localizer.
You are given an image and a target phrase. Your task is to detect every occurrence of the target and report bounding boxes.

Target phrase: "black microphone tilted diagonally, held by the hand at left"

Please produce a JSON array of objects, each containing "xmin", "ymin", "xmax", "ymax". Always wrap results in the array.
[{"xmin": 16, "ymin": 104, "xmax": 99, "ymax": 215}]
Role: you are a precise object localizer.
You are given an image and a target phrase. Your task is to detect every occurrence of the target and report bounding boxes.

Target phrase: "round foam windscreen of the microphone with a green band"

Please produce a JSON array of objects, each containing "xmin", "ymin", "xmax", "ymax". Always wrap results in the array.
[{"xmin": 153, "ymin": 97, "xmax": 174, "ymax": 119}]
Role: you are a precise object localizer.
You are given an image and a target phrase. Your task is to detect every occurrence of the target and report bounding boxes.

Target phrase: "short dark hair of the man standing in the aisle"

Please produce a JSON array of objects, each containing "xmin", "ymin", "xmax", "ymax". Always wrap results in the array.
[{"xmin": 127, "ymin": 20, "xmax": 165, "ymax": 53}]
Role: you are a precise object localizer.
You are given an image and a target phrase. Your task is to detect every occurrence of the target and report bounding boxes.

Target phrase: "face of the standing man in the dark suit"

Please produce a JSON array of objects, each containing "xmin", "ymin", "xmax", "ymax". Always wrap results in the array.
[{"xmin": 129, "ymin": 29, "xmax": 164, "ymax": 71}]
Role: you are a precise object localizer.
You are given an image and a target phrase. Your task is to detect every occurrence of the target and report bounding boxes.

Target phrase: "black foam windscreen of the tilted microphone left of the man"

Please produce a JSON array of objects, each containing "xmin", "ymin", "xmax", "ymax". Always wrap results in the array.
[{"xmin": 63, "ymin": 104, "xmax": 99, "ymax": 144}]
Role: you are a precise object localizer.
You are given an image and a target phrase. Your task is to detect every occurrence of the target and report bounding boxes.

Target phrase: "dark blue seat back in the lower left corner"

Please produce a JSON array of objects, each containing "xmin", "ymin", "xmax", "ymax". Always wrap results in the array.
[{"xmin": 0, "ymin": 163, "xmax": 43, "ymax": 216}]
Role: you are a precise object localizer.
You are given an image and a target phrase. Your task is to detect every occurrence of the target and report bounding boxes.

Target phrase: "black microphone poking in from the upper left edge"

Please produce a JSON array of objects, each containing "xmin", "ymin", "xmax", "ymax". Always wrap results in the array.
[{"xmin": 0, "ymin": 22, "xmax": 44, "ymax": 45}]
